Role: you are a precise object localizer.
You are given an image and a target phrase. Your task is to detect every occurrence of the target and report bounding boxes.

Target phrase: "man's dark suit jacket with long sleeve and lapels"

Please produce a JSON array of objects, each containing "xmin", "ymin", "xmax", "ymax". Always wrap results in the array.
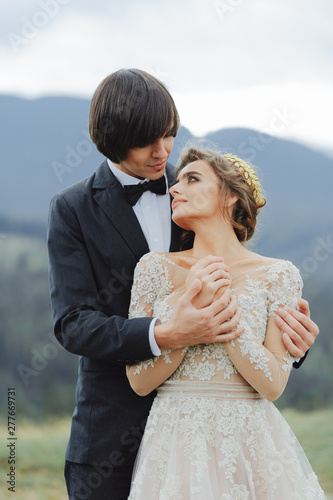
[{"xmin": 48, "ymin": 161, "xmax": 181, "ymax": 492}]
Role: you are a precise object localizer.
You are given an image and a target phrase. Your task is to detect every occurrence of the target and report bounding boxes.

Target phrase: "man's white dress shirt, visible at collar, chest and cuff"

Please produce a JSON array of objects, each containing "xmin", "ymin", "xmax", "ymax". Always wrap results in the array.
[{"xmin": 107, "ymin": 159, "xmax": 171, "ymax": 356}]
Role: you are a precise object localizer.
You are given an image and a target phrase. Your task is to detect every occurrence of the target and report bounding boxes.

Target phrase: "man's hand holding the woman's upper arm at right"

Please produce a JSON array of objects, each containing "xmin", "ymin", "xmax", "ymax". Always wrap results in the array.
[{"xmin": 275, "ymin": 299, "xmax": 319, "ymax": 368}]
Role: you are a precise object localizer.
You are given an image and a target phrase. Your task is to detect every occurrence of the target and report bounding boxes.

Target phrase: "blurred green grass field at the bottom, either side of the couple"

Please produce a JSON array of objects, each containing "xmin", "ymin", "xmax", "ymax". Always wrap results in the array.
[{"xmin": 0, "ymin": 409, "xmax": 333, "ymax": 500}]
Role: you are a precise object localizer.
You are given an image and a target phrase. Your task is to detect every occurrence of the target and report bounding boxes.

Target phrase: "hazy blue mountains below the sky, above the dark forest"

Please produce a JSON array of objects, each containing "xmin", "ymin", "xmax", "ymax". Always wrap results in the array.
[{"xmin": 0, "ymin": 95, "xmax": 333, "ymax": 266}]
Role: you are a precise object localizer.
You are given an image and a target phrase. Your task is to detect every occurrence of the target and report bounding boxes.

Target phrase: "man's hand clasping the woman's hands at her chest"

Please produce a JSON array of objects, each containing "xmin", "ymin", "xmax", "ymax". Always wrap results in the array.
[{"xmin": 154, "ymin": 279, "xmax": 244, "ymax": 350}]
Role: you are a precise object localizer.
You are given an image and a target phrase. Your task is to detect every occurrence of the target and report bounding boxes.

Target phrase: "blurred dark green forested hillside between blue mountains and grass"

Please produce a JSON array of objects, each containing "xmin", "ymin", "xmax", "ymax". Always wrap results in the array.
[{"xmin": 0, "ymin": 235, "xmax": 333, "ymax": 419}]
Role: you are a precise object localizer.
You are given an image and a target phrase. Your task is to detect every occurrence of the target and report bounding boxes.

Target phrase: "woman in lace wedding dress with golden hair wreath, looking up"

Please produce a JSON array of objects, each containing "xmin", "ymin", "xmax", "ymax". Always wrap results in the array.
[{"xmin": 126, "ymin": 148, "xmax": 325, "ymax": 500}]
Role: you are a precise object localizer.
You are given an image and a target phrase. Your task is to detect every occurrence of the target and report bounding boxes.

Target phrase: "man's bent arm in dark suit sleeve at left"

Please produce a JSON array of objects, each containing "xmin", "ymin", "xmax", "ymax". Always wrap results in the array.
[{"xmin": 48, "ymin": 191, "xmax": 152, "ymax": 363}]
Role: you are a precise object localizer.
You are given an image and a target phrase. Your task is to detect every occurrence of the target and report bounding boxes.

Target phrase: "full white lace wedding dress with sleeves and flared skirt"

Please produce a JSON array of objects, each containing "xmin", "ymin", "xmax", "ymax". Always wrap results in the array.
[{"xmin": 129, "ymin": 252, "xmax": 325, "ymax": 500}]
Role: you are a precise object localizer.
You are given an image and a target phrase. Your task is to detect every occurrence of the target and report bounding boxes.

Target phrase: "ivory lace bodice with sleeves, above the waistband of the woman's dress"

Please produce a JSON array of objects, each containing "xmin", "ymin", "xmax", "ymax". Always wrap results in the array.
[{"xmin": 129, "ymin": 252, "xmax": 302, "ymax": 396}]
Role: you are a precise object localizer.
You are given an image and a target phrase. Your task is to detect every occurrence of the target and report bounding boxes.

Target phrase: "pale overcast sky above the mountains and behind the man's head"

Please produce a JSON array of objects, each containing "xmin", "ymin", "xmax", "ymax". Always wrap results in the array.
[{"xmin": 0, "ymin": 0, "xmax": 333, "ymax": 149}]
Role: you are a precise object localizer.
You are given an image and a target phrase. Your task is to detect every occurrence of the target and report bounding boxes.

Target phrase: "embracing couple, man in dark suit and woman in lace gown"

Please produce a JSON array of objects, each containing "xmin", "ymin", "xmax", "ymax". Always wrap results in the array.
[{"xmin": 48, "ymin": 70, "xmax": 325, "ymax": 500}]
